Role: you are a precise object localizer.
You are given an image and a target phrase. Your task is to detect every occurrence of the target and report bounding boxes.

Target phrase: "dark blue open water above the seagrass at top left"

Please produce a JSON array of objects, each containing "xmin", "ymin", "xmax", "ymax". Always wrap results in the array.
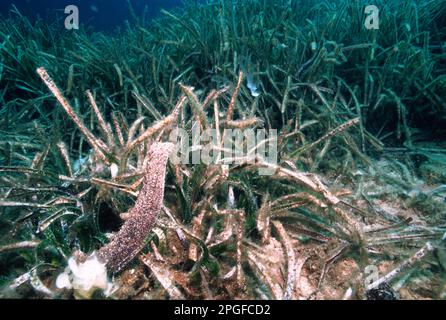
[{"xmin": 0, "ymin": 0, "xmax": 190, "ymax": 31}]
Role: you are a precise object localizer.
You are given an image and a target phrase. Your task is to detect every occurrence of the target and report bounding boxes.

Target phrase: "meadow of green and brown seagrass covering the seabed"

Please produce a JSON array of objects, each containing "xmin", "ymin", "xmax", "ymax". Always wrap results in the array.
[{"xmin": 0, "ymin": 0, "xmax": 446, "ymax": 300}]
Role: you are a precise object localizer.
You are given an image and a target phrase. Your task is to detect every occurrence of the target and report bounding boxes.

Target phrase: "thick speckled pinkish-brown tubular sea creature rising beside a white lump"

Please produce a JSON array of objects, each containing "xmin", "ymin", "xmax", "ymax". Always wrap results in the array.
[{"xmin": 98, "ymin": 143, "xmax": 173, "ymax": 272}]
